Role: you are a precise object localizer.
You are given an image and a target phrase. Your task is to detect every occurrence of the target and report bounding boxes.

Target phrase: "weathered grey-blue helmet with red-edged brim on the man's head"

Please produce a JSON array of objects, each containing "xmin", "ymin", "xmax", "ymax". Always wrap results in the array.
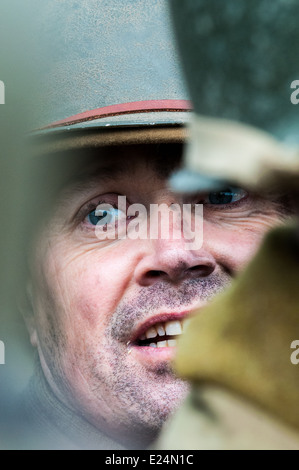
[{"xmin": 34, "ymin": 0, "xmax": 191, "ymax": 151}]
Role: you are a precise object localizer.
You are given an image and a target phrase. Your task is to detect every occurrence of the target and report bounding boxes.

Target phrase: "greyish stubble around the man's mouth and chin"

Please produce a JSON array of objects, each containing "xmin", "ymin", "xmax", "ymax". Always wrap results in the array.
[{"xmin": 85, "ymin": 274, "xmax": 231, "ymax": 445}]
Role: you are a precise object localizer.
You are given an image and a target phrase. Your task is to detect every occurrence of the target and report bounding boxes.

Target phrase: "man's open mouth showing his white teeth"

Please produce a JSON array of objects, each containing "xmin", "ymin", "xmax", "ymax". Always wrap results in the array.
[{"xmin": 132, "ymin": 318, "xmax": 190, "ymax": 348}]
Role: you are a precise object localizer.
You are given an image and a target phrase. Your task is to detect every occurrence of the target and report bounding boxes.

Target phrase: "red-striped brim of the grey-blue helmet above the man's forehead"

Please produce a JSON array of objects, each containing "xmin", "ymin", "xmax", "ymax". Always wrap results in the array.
[{"xmin": 32, "ymin": 100, "xmax": 191, "ymax": 153}]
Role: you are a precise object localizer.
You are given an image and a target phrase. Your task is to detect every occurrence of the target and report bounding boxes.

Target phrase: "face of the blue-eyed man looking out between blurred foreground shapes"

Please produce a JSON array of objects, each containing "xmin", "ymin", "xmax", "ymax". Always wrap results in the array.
[{"xmin": 31, "ymin": 147, "xmax": 292, "ymax": 445}]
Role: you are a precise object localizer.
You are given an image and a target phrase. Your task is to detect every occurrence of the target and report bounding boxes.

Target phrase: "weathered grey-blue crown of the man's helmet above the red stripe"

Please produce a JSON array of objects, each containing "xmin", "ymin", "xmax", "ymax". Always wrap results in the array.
[{"xmin": 30, "ymin": 0, "xmax": 188, "ymax": 132}]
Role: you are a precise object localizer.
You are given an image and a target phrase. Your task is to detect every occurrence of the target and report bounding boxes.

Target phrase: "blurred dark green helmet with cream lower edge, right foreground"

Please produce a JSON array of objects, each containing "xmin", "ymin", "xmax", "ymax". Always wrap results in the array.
[{"xmin": 170, "ymin": 0, "xmax": 299, "ymax": 189}]
